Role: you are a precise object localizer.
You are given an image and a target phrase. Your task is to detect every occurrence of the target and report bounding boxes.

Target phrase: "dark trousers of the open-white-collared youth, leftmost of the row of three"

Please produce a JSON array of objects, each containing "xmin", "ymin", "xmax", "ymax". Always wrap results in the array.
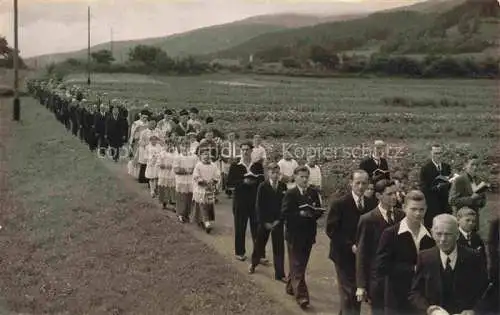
[{"xmin": 233, "ymin": 207, "xmax": 257, "ymax": 256}]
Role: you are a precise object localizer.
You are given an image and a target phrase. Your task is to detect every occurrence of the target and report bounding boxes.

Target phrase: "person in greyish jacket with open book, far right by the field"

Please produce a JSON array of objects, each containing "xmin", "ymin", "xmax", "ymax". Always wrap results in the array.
[{"xmin": 449, "ymin": 155, "xmax": 486, "ymax": 216}]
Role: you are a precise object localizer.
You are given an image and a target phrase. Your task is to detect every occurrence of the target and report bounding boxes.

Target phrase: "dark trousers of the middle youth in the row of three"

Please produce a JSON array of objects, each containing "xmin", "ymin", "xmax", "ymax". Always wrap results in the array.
[{"xmin": 252, "ymin": 223, "xmax": 285, "ymax": 279}]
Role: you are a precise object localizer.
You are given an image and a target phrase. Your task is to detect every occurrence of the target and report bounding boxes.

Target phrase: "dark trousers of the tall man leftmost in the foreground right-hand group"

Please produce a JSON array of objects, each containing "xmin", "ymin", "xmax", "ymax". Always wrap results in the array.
[{"xmin": 335, "ymin": 262, "xmax": 361, "ymax": 315}]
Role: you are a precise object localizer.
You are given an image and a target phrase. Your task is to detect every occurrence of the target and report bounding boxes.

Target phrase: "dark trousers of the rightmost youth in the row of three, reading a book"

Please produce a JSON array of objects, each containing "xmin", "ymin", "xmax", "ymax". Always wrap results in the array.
[{"xmin": 286, "ymin": 242, "xmax": 312, "ymax": 302}]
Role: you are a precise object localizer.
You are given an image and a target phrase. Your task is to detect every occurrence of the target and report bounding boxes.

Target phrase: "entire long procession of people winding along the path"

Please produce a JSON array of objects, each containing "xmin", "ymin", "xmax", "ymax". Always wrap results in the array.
[{"xmin": 28, "ymin": 80, "xmax": 500, "ymax": 315}]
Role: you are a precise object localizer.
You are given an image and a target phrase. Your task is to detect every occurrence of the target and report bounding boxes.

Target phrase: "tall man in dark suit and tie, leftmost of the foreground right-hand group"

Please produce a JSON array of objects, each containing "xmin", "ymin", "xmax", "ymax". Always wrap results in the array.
[{"xmin": 326, "ymin": 170, "xmax": 377, "ymax": 315}]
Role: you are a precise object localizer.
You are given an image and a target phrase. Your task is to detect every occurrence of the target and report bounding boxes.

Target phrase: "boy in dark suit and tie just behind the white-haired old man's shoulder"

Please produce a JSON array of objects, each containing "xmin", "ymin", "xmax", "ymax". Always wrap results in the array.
[{"xmin": 457, "ymin": 207, "xmax": 486, "ymax": 266}]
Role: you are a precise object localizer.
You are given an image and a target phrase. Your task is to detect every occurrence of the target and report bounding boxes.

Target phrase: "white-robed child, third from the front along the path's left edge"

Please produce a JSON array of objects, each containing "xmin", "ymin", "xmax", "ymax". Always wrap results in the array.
[{"xmin": 158, "ymin": 139, "xmax": 177, "ymax": 211}]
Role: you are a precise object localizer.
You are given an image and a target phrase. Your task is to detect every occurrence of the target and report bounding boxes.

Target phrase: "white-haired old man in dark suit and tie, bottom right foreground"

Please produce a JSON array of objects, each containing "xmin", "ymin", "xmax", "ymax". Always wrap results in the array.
[{"xmin": 409, "ymin": 214, "xmax": 488, "ymax": 315}]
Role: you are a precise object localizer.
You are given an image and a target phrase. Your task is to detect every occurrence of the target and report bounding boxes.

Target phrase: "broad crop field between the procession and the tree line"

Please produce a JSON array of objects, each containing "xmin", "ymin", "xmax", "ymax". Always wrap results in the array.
[{"xmin": 67, "ymin": 74, "xmax": 500, "ymax": 198}]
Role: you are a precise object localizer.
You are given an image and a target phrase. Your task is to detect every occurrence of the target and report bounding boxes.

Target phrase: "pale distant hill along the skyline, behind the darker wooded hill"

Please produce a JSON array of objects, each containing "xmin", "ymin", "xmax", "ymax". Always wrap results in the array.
[{"xmin": 26, "ymin": 14, "xmax": 364, "ymax": 67}]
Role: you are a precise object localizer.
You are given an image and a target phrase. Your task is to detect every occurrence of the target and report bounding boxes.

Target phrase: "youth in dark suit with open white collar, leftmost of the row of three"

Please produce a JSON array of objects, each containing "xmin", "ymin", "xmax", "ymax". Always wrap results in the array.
[{"xmin": 227, "ymin": 141, "xmax": 264, "ymax": 261}]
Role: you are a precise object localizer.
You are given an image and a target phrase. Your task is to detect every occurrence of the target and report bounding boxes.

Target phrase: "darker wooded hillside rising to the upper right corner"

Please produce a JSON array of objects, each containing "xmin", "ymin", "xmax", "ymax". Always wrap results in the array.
[{"xmin": 209, "ymin": 0, "xmax": 500, "ymax": 62}]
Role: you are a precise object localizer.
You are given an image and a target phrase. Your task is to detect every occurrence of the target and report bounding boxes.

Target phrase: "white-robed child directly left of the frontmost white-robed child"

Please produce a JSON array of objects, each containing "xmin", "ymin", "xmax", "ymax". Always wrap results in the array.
[{"xmin": 173, "ymin": 138, "xmax": 198, "ymax": 223}]
